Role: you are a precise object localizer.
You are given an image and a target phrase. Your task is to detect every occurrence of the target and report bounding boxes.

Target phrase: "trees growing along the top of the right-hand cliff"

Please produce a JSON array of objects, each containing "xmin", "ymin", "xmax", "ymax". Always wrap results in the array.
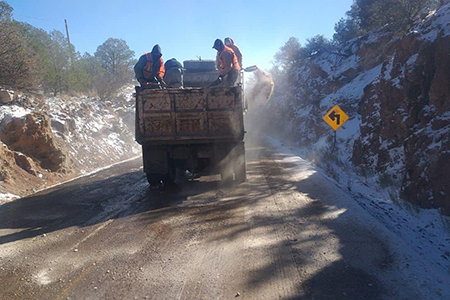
[{"xmin": 271, "ymin": 0, "xmax": 442, "ymax": 81}]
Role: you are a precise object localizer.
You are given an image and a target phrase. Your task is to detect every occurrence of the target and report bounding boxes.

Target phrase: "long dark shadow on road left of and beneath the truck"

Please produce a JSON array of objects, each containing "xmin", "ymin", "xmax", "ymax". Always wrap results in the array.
[{"xmin": 0, "ymin": 159, "xmax": 241, "ymax": 245}]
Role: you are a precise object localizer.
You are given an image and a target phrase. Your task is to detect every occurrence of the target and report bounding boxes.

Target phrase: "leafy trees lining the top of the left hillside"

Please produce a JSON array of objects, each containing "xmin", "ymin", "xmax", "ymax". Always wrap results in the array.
[{"xmin": 0, "ymin": 1, "xmax": 135, "ymax": 99}]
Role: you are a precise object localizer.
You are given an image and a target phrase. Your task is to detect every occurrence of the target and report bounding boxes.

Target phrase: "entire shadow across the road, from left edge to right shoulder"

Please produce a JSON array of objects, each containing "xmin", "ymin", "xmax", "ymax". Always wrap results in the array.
[{"xmin": 0, "ymin": 139, "xmax": 414, "ymax": 299}]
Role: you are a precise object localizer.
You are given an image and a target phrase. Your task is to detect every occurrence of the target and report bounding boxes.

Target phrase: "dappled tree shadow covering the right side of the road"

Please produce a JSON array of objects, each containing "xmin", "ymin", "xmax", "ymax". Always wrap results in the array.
[{"xmin": 162, "ymin": 139, "xmax": 400, "ymax": 299}]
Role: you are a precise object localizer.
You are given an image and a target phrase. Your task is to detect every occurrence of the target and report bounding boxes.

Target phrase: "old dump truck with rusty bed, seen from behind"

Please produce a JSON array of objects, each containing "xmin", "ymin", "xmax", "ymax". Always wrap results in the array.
[{"xmin": 136, "ymin": 61, "xmax": 246, "ymax": 185}]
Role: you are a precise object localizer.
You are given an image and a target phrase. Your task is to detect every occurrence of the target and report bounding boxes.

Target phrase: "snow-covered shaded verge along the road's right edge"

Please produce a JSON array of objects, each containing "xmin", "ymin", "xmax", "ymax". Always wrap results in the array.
[{"xmin": 266, "ymin": 136, "xmax": 450, "ymax": 299}]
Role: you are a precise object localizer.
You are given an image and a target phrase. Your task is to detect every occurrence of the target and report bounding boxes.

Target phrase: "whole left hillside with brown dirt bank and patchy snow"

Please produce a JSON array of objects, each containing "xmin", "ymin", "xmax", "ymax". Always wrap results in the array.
[{"xmin": 0, "ymin": 87, "xmax": 140, "ymax": 203}]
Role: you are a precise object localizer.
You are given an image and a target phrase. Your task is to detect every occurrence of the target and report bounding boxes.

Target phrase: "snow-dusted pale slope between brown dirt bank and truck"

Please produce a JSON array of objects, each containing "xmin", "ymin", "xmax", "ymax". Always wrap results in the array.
[{"xmin": 47, "ymin": 87, "xmax": 140, "ymax": 170}]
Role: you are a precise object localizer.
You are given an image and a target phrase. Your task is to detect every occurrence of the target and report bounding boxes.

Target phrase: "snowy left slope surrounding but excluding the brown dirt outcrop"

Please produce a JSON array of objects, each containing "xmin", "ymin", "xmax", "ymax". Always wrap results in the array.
[{"xmin": 0, "ymin": 86, "xmax": 141, "ymax": 203}]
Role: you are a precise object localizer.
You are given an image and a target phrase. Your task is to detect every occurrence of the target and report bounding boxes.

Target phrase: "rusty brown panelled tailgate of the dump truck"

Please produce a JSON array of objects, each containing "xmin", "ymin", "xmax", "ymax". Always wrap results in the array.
[{"xmin": 136, "ymin": 86, "xmax": 244, "ymax": 144}]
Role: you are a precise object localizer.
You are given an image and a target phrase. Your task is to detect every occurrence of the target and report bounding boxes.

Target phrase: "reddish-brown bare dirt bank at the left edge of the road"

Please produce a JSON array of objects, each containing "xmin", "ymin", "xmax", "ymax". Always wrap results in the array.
[{"xmin": 0, "ymin": 113, "xmax": 69, "ymax": 196}]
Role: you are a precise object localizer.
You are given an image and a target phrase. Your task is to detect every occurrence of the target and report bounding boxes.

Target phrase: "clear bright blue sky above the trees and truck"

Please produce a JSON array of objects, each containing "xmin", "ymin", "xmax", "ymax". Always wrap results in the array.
[{"xmin": 6, "ymin": 0, "xmax": 353, "ymax": 69}]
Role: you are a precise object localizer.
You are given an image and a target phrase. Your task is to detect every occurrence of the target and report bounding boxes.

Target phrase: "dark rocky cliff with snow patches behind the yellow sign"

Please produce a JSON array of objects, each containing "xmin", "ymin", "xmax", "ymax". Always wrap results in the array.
[{"xmin": 271, "ymin": 4, "xmax": 450, "ymax": 214}]
